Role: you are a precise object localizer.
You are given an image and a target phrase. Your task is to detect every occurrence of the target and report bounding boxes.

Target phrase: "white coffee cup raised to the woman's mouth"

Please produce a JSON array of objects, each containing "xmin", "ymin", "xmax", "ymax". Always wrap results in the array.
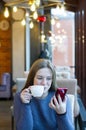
[{"xmin": 30, "ymin": 85, "xmax": 44, "ymax": 97}]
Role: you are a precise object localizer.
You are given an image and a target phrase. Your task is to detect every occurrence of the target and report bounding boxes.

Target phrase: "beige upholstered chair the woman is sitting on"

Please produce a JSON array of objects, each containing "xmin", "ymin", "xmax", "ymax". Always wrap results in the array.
[{"xmin": 11, "ymin": 78, "xmax": 77, "ymax": 130}]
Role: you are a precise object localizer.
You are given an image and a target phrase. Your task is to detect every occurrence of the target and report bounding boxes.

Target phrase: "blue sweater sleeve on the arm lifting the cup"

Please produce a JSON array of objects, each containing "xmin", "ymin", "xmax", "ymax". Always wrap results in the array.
[{"xmin": 14, "ymin": 93, "xmax": 33, "ymax": 130}]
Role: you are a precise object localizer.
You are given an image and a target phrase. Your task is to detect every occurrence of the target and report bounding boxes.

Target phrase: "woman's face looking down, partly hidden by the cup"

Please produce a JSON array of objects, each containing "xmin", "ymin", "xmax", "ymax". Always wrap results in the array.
[{"xmin": 34, "ymin": 68, "xmax": 52, "ymax": 94}]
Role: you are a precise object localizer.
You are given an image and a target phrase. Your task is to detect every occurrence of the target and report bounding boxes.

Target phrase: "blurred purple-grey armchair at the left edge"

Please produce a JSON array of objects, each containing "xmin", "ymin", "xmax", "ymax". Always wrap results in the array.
[{"xmin": 0, "ymin": 73, "xmax": 11, "ymax": 98}]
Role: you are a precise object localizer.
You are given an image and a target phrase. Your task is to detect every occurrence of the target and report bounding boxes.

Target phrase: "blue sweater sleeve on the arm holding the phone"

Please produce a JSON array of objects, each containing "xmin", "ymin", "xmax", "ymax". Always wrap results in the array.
[{"xmin": 57, "ymin": 99, "xmax": 75, "ymax": 130}]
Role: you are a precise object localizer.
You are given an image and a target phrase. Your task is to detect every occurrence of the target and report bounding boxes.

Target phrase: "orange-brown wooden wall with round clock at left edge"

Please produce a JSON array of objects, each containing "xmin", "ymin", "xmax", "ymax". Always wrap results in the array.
[{"xmin": 0, "ymin": 14, "xmax": 12, "ymax": 83}]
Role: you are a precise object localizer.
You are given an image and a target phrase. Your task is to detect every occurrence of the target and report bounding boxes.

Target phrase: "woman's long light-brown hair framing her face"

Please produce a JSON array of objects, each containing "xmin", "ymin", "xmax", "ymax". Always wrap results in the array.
[{"xmin": 22, "ymin": 59, "xmax": 57, "ymax": 90}]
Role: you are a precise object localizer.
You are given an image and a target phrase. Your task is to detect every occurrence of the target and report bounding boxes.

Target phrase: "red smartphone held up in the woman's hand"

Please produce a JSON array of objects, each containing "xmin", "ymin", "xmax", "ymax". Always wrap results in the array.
[{"xmin": 55, "ymin": 88, "xmax": 68, "ymax": 101}]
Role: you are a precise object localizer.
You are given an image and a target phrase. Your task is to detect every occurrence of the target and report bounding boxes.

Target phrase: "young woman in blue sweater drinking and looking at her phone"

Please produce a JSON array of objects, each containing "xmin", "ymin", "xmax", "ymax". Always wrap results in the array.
[{"xmin": 14, "ymin": 59, "xmax": 74, "ymax": 130}]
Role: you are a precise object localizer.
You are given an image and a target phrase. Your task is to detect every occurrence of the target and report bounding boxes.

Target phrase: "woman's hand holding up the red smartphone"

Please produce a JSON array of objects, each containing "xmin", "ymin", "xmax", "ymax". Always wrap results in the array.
[{"xmin": 49, "ymin": 95, "xmax": 67, "ymax": 114}]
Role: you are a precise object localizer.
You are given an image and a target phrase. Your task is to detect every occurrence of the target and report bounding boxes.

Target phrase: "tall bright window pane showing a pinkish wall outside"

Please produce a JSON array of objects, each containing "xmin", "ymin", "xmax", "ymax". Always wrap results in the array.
[{"xmin": 51, "ymin": 9, "xmax": 75, "ymax": 75}]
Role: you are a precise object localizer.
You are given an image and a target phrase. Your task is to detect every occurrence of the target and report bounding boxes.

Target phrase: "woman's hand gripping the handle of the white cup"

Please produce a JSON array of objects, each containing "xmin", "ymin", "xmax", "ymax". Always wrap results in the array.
[{"xmin": 20, "ymin": 88, "xmax": 32, "ymax": 103}]
